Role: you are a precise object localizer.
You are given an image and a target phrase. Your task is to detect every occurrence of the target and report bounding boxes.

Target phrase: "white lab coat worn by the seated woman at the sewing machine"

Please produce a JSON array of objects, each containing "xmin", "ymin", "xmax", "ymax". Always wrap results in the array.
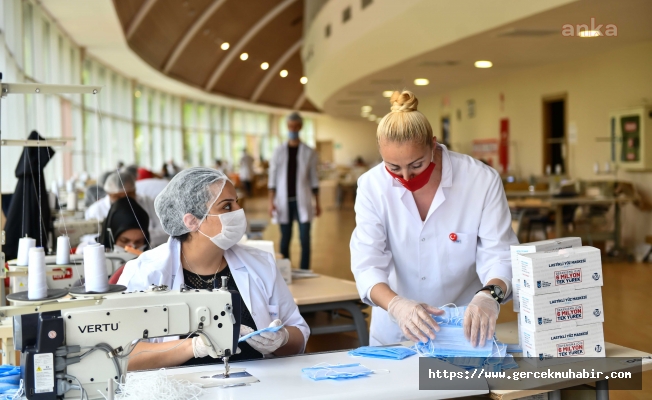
[{"xmin": 118, "ymin": 238, "xmax": 310, "ymax": 352}]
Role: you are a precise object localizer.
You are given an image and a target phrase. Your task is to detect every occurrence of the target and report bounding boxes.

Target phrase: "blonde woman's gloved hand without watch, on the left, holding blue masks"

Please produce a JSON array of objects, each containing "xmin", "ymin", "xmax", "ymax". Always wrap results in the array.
[{"xmin": 387, "ymin": 296, "xmax": 445, "ymax": 343}]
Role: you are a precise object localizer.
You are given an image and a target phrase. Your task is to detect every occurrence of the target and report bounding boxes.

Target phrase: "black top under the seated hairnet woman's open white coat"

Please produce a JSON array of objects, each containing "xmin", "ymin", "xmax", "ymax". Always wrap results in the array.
[{"xmin": 182, "ymin": 265, "xmax": 263, "ymax": 366}]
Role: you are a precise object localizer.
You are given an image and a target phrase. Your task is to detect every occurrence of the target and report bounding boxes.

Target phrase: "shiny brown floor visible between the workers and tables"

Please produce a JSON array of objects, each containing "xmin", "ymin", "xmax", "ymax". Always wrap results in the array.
[{"xmin": 245, "ymin": 198, "xmax": 652, "ymax": 400}]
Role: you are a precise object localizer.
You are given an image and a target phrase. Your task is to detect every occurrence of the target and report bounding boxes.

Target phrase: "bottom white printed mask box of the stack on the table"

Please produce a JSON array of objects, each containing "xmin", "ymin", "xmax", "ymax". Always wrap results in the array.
[{"xmin": 521, "ymin": 324, "xmax": 605, "ymax": 368}]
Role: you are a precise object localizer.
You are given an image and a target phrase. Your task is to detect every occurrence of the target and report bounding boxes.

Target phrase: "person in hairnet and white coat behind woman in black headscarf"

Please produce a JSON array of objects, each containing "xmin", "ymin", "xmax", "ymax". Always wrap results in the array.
[{"xmin": 84, "ymin": 170, "xmax": 168, "ymax": 247}]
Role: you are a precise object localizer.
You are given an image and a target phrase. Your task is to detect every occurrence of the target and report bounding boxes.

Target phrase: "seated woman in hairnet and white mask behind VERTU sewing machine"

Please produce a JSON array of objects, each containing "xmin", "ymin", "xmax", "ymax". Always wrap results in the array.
[{"xmin": 118, "ymin": 168, "xmax": 310, "ymax": 370}]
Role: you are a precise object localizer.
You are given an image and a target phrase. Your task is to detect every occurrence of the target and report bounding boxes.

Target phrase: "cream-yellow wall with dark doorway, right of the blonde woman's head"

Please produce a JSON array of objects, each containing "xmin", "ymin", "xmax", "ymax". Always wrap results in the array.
[{"xmin": 419, "ymin": 38, "xmax": 652, "ymax": 245}]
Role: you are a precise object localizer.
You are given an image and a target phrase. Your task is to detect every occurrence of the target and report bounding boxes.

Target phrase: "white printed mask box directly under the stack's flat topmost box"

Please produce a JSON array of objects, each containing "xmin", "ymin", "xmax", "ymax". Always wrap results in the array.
[{"xmin": 517, "ymin": 246, "xmax": 603, "ymax": 295}]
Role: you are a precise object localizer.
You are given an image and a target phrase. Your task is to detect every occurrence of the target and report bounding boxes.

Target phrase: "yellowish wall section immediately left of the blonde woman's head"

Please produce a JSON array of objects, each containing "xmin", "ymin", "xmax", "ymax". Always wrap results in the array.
[{"xmin": 315, "ymin": 115, "xmax": 380, "ymax": 166}]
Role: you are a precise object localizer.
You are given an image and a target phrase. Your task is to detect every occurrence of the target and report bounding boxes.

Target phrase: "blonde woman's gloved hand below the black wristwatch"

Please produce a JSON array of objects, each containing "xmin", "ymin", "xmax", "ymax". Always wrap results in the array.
[{"xmin": 464, "ymin": 291, "xmax": 500, "ymax": 347}]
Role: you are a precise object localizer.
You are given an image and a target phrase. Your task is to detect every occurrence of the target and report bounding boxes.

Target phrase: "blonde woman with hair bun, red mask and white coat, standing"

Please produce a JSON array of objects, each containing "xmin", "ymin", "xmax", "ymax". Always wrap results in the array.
[{"xmin": 351, "ymin": 91, "xmax": 518, "ymax": 346}]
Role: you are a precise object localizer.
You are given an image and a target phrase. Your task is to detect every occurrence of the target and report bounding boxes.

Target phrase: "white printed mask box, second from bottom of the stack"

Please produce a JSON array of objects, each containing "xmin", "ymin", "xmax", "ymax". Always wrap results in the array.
[{"xmin": 519, "ymin": 287, "xmax": 604, "ymax": 332}]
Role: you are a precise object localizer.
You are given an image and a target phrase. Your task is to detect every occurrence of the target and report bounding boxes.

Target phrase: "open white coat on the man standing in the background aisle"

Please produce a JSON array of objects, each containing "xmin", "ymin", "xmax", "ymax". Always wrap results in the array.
[{"xmin": 267, "ymin": 142, "xmax": 319, "ymax": 224}]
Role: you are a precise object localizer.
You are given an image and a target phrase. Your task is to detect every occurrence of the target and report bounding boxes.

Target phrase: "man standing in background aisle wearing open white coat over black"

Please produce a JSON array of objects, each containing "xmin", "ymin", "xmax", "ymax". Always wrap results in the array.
[{"xmin": 267, "ymin": 112, "xmax": 321, "ymax": 269}]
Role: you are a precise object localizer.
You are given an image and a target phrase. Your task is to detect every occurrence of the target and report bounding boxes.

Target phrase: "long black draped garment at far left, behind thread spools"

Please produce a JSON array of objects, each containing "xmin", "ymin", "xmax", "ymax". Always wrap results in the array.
[{"xmin": 2, "ymin": 131, "xmax": 54, "ymax": 260}]
